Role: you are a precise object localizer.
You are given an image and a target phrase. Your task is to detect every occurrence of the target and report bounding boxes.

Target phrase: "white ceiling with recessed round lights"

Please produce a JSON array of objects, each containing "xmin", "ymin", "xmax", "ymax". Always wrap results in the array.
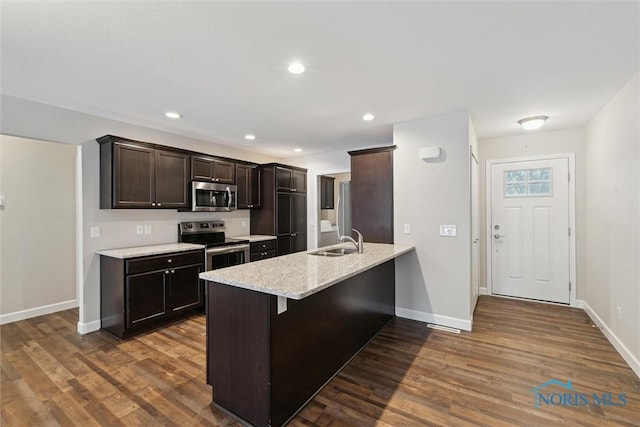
[{"xmin": 1, "ymin": 0, "xmax": 640, "ymax": 157}]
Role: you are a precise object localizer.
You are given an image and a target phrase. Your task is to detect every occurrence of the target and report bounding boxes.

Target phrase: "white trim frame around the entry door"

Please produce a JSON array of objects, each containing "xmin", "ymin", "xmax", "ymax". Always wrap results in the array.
[{"xmin": 485, "ymin": 153, "xmax": 578, "ymax": 307}]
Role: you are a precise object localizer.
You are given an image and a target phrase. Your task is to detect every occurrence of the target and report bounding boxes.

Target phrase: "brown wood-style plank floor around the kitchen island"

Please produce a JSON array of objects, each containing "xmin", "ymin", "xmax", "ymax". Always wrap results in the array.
[{"xmin": 0, "ymin": 297, "xmax": 640, "ymax": 426}]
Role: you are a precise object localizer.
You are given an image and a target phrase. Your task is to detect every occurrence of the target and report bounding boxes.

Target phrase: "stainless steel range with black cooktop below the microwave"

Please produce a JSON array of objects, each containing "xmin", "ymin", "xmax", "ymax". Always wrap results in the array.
[{"xmin": 178, "ymin": 221, "xmax": 249, "ymax": 270}]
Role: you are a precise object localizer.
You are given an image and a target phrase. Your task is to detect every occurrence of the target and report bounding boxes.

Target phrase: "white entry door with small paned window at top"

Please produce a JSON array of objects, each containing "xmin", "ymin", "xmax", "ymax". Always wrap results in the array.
[{"xmin": 490, "ymin": 158, "xmax": 570, "ymax": 304}]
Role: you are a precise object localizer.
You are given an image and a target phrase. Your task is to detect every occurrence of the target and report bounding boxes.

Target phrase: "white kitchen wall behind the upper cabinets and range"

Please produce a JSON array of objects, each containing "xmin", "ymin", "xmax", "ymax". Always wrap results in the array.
[{"xmin": 0, "ymin": 95, "xmax": 278, "ymax": 332}]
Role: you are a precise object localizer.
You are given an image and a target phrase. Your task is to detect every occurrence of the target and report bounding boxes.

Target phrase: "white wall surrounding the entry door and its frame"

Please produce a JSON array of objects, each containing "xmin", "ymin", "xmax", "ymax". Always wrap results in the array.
[{"xmin": 479, "ymin": 129, "xmax": 585, "ymax": 299}]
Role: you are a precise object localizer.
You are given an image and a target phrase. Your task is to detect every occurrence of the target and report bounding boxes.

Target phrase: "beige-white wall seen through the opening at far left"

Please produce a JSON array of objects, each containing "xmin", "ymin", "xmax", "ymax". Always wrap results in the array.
[{"xmin": 0, "ymin": 135, "xmax": 77, "ymax": 324}]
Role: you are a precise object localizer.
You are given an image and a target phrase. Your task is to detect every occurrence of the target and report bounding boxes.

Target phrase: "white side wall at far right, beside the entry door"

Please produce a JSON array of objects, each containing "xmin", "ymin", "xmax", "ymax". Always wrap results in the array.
[{"xmin": 583, "ymin": 74, "xmax": 640, "ymax": 376}]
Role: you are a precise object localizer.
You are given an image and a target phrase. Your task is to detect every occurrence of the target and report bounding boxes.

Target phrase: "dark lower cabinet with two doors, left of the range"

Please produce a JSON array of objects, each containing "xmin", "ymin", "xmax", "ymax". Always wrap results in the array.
[{"xmin": 100, "ymin": 250, "xmax": 204, "ymax": 339}]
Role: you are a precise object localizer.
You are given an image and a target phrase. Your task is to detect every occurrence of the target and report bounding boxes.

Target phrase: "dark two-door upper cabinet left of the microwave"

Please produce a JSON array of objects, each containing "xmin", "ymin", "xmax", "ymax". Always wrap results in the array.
[{"xmin": 98, "ymin": 135, "xmax": 190, "ymax": 209}]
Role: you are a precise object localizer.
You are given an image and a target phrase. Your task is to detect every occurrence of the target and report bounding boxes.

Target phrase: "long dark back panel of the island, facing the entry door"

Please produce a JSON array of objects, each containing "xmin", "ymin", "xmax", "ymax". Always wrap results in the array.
[{"xmin": 270, "ymin": 260, "xmax": 395, "ymax": 426}]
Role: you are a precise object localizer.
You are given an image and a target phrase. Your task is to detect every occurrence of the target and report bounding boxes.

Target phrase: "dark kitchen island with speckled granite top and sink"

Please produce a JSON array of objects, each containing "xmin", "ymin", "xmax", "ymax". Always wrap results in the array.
[{"xmin": 200, "ymin": 243, "xmax": 413, "ymax": 426}]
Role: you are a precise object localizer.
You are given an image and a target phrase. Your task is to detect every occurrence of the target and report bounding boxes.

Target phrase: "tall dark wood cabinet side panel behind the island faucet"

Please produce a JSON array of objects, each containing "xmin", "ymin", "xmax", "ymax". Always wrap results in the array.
[{"xmin": 349, "ymin": 145, "xmax": 396, "ymax": 243}]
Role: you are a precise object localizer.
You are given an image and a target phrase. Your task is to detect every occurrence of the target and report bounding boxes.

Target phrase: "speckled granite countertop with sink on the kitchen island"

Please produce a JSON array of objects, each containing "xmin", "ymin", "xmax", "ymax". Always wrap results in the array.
[{"xmin": 200, "ymin": 242, "xmax": 414, "ymax": 299}]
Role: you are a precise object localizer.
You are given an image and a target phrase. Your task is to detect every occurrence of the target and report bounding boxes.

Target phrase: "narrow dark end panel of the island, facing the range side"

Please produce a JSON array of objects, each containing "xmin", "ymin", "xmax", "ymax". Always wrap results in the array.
[{"xmin": 207, "ymin": 282, "xmax": 270, "ymax": 426}]
